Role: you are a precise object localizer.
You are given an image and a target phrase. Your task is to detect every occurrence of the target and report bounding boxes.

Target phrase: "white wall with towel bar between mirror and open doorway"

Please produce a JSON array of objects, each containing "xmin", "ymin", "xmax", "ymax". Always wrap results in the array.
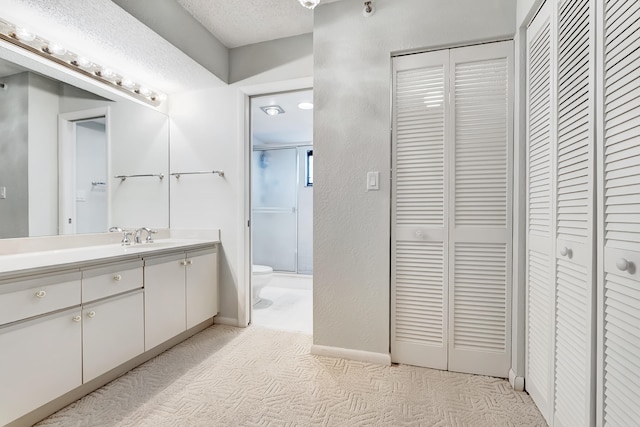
[{"xmin": 169, "ymin": 36, "xmax": 313, "ymax": 325}]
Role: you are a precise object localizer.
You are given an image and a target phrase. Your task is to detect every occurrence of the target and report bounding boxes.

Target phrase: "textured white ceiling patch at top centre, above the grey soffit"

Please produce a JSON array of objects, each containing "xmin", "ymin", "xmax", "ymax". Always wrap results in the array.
[{"xmin": 176, "ymin": 0, "xmax": 338, "ymax": 48}]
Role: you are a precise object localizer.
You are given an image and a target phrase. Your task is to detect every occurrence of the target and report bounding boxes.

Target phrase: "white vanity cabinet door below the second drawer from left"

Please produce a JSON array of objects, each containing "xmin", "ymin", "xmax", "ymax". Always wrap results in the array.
[{"xmin": 82, "ymin": 291, "xmax": 144, "ymax": 383}]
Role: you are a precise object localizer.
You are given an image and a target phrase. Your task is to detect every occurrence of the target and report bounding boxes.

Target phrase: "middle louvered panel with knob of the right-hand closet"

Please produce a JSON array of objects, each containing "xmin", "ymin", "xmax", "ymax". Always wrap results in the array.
[{"xmin": 553, "ymin": 0, "xmax": 595, "ymax": 427}]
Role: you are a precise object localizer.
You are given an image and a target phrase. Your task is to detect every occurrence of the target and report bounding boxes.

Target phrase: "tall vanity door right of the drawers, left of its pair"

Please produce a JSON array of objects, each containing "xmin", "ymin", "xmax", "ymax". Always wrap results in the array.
[{"xmin": 144, "ymin": 254, "xmax": 187, "ymax": 350}]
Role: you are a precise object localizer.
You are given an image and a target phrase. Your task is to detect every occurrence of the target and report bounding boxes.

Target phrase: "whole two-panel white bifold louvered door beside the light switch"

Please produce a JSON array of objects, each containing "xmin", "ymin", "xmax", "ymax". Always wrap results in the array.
[{"xmin": 391, "ymin": 42, "xmax": 513, "ymax": 377}]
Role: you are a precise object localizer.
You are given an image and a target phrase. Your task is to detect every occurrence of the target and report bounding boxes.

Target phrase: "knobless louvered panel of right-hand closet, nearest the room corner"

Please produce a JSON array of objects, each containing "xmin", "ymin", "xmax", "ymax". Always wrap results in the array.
[{"xmin": 525, "ymin": 2, "xmax": 555, "ymax": 423}]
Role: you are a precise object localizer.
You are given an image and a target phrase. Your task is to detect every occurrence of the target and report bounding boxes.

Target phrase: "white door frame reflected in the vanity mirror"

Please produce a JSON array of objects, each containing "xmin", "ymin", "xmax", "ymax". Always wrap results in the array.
[{"xmin": 58, "ymin": 107, "xmax": 111, "ymax": 234}]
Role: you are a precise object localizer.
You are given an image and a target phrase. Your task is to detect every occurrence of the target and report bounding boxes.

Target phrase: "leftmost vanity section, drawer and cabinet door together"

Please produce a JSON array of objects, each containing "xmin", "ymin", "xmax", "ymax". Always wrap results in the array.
[{"xmin": 0, "ymin": 271, "xmax": 82, "ymax": 425}]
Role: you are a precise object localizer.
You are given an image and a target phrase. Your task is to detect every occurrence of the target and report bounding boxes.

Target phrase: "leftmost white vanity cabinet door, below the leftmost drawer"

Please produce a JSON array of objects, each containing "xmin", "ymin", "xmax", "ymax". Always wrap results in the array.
[{"xmin": 0, "ymin": 308, "xmax": 82, "ymax": 425}]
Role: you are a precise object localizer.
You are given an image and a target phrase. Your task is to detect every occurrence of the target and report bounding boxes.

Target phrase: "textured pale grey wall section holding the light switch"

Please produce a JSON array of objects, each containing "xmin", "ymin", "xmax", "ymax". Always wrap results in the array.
[{"xmin": 313, "ymin": 0, "xmax": 516, "ymax": 354}]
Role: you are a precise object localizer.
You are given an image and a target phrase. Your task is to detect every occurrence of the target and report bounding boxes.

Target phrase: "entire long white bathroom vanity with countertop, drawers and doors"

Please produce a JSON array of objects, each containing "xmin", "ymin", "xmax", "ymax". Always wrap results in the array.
[{"xmin": 0, "ymin": 233, "xmax": 219, "ymax": 425}]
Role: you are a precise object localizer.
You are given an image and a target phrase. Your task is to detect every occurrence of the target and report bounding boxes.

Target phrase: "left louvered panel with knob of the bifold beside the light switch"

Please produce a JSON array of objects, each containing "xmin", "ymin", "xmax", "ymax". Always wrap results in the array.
[{"xmin": 391, "ymin": 51, "xmax": 449, "ymax": 369}]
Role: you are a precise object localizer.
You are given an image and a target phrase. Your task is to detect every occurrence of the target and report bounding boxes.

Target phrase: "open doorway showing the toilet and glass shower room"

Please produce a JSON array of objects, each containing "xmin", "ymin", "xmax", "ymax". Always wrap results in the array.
[{"xmin": 250, "ymin": 90, "xmax": 313, "ymax": 333}]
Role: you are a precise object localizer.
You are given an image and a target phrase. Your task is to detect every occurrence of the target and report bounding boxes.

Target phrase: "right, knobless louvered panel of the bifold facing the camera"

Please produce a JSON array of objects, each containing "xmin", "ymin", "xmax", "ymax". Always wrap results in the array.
[{"xmin": 447, "ymin": 42, "xmax": 513, "ymax": 377}]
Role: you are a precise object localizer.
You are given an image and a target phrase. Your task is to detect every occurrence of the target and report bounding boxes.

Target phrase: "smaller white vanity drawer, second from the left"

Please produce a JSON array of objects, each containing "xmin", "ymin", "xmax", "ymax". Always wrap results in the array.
[{"xmin": 82, "ymin": 261, "xmax": 143, "ymax": 303}]
